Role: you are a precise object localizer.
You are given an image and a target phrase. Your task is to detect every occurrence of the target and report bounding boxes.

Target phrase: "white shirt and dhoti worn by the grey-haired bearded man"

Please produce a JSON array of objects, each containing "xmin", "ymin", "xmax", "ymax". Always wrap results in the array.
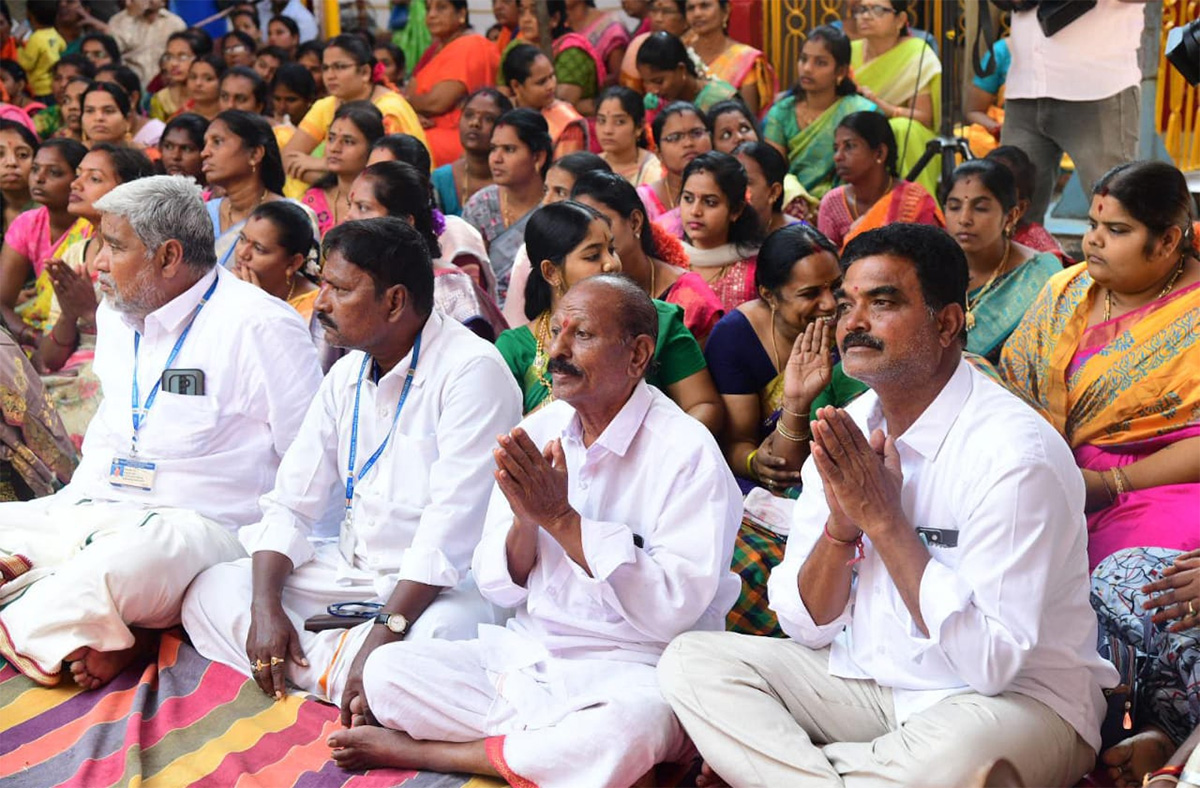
[{"xmin": 0, "ymin": 270, "xmax": 320, "ymax": 684}]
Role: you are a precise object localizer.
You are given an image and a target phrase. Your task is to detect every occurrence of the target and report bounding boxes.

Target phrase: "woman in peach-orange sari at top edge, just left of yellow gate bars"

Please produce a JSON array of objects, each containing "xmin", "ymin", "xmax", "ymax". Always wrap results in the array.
[{"xmin": 686, "ymin": 0, "xmax": 779, "ymax": 115}]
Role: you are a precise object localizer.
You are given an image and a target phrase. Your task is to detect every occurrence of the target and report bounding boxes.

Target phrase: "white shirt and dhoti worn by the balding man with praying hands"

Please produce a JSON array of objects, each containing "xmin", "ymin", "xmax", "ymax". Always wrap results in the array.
[{"xmin": 364, "ymin": 383, "xmax": 742, "ymax": 786}]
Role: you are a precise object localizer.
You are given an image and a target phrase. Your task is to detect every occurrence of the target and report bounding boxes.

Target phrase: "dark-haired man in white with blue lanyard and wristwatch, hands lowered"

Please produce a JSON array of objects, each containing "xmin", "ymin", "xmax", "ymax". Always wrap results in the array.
[{"xmin": 184, "ymin": 218, "xmax": 521, "ymax": 722}]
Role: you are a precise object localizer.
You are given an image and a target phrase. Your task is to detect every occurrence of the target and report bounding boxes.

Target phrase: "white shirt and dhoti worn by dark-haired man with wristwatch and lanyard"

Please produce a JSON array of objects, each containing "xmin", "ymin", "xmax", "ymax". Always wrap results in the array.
[{"xmin": 184, "ymin": 312, "xmax": 521, "ymax": 702}]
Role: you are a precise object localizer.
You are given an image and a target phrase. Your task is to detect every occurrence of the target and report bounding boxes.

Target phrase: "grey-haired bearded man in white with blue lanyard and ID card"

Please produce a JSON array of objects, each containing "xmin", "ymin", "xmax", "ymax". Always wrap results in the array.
[{"xmin": 0, "ymin": 175, "xmax": 320, "ymax": 688}]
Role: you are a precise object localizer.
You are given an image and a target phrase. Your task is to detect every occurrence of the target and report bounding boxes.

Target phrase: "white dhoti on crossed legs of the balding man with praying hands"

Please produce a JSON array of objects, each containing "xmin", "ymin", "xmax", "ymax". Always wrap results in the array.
[{"xmin": 362, "ymin": 626, "xmax": 692, "ymax": 788}]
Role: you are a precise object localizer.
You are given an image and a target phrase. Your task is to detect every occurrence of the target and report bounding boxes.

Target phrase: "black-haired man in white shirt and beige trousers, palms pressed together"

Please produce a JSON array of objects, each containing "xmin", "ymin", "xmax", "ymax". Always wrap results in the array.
[{"xmin": 659, "ymin": 224, "xmax": 1116, "ymax": 786}]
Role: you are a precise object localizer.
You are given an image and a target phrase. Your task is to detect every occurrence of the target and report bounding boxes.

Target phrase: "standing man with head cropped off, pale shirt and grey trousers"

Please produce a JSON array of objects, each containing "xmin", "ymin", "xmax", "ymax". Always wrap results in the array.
[{"xmin": 1001, "ymin": 0, "xmax": 1145, "ymax": 222}]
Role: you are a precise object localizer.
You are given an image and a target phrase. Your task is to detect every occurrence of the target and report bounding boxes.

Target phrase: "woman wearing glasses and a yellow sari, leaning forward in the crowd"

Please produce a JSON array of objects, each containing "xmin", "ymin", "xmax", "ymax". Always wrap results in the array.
[{"xmin": 283, "ymin": 35, "xmax": 428, "ymax": 191}]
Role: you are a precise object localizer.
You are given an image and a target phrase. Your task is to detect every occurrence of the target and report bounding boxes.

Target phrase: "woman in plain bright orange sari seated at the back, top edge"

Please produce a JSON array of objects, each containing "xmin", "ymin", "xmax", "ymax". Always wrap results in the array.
[{"xmin": 406, "ymin": 0, "xmax": 500, "ymax": 167}]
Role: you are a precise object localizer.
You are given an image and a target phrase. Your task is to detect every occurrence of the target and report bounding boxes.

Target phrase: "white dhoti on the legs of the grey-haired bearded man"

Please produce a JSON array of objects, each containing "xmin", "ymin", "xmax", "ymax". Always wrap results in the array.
[{"xmin": 0, "ymin": 499, "xmax": 245, "ymax": 685}]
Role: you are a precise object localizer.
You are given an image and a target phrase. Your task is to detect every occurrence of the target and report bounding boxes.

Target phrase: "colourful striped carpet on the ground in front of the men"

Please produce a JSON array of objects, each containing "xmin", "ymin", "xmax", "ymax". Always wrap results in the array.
[{"xmin": 0, "ymin": 633, "xmax": 499, "ymax": 788}]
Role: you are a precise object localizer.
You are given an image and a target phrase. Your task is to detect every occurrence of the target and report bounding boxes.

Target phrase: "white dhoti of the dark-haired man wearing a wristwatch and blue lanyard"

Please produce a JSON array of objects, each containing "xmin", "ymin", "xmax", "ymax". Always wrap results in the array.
[{"xmin": 182, "ymin": 545, "xmax": 504, "ymax": 704}]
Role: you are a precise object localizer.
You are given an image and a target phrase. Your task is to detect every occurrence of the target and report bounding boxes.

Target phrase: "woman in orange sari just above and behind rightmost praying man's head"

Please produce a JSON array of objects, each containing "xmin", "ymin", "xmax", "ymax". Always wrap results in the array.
[{"xmin": 817, "ymin": 112, "xmax": 946, "ymax": 248}]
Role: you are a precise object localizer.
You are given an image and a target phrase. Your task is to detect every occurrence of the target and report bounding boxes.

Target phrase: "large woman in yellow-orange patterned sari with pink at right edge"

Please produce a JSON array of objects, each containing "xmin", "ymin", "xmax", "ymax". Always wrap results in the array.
[{"xmin": 1000, "ymin": 162, "xmax": 1200, "ymax": 567}]
